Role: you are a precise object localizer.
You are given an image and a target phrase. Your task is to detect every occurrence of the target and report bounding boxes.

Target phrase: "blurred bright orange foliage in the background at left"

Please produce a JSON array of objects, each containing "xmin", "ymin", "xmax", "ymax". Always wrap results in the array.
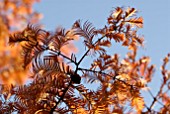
[{"xmin": 0, "ymin": 0, "xmax": 41, "ymax": 84}]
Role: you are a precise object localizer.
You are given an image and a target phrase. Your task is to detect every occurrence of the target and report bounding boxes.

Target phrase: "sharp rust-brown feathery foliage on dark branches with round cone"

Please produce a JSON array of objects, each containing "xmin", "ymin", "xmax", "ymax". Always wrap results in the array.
[{"xmin": 0, "ymin": 7, "xmax": 170, "ymax": 114}]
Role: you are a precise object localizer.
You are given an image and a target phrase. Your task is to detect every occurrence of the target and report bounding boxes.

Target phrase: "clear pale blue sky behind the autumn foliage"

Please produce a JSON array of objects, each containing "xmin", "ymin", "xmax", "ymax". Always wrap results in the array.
[{"xmin": 34, "ymin": 0, "xmax": 170, "ymax": 110}]
